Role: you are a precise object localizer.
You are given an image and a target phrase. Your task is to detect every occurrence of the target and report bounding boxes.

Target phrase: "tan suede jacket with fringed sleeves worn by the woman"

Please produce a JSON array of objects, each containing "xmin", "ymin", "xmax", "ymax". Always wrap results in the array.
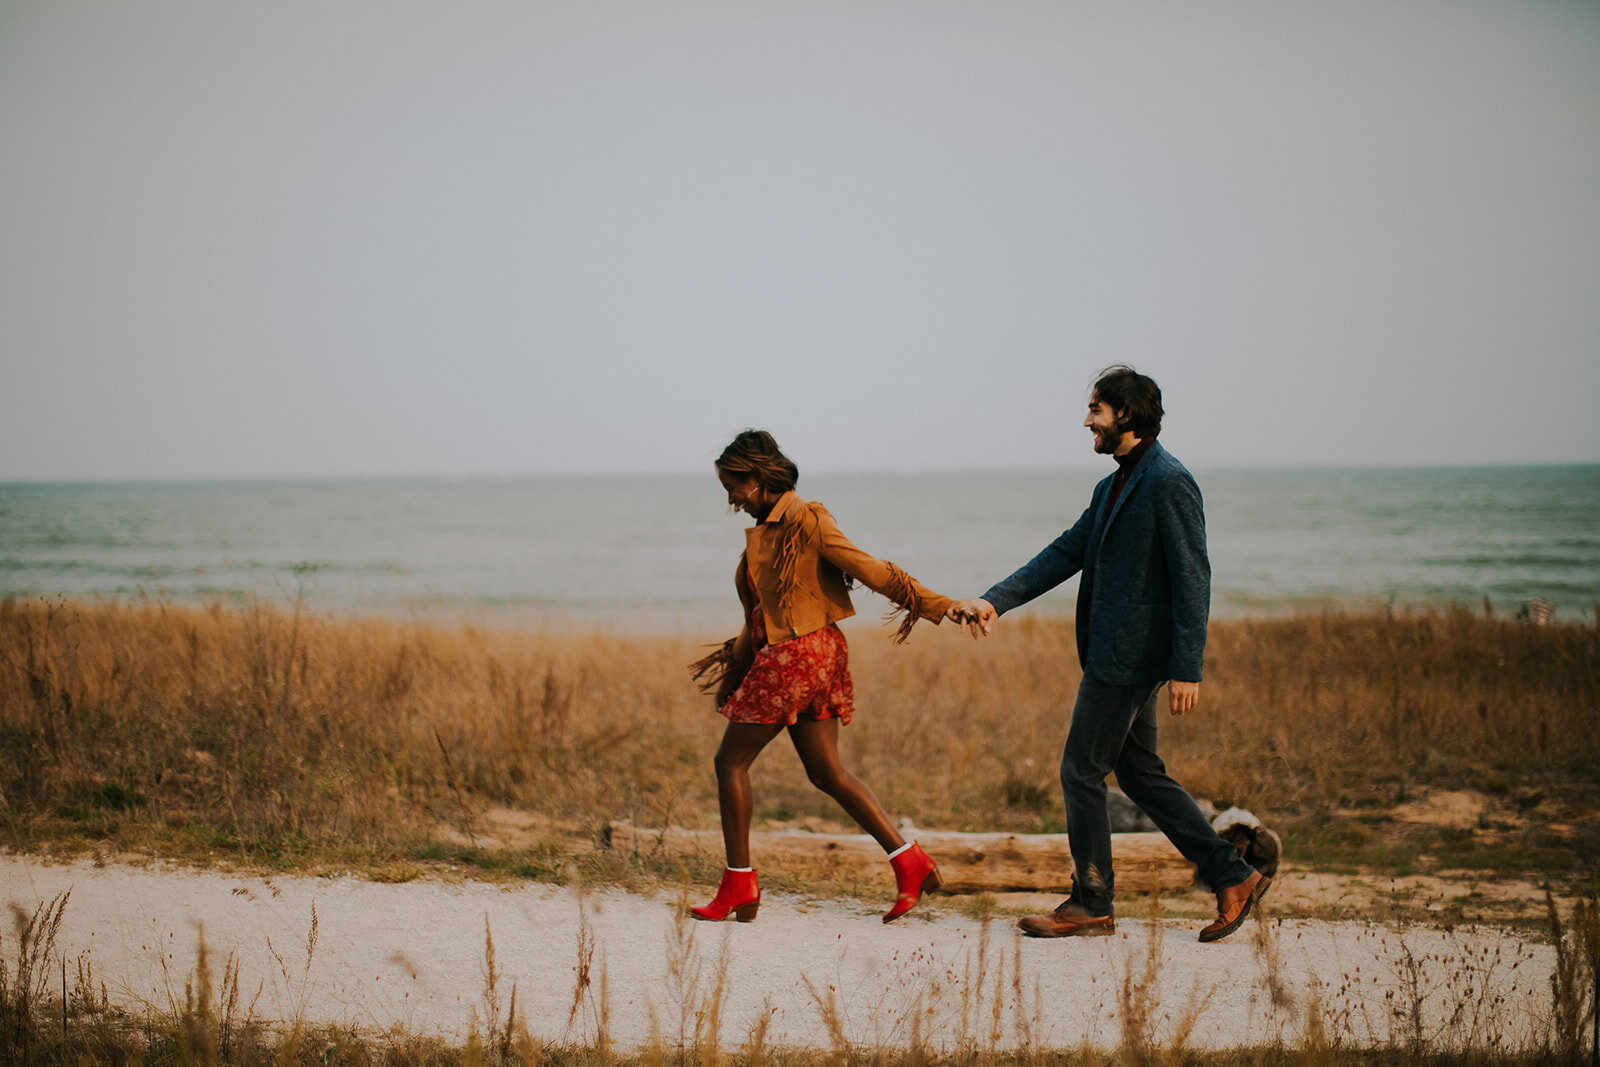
[{"xmin": 691, "ymin": 491, "xmax": 950, "ymax": 704}]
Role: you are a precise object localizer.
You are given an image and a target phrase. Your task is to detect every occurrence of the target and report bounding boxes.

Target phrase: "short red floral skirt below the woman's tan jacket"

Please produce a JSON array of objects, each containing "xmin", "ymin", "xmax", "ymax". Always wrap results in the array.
[{"xmin": 722, "ymin": 605, "xmax": 856, "ymax": 726}]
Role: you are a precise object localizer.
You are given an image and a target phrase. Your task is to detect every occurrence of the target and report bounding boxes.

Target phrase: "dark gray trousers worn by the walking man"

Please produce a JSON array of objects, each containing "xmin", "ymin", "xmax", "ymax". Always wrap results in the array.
[{"xmin": 1061, "ymin": 672, "xmax": 1251, "ymax": 915}]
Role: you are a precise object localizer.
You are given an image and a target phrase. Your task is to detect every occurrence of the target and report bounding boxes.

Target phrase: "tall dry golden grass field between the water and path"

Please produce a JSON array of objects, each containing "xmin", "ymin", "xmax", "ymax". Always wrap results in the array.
[{"xmin": 0, "ymin": 601, "xmax": 1600, "ymax": 877}]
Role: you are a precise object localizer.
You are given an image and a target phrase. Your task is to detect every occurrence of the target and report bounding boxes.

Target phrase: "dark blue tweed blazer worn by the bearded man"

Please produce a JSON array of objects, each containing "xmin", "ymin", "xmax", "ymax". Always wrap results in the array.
[{"xmin": 984, "ymin": 442, "xmax": 1211, "ymax": 685}]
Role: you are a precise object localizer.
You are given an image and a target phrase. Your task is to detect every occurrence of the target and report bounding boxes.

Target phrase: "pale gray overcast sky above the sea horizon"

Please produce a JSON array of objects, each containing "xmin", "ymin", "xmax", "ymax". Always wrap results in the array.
[{"xmin": 0, "ymin": 0, "xmax": 1600, "ymax": 480}]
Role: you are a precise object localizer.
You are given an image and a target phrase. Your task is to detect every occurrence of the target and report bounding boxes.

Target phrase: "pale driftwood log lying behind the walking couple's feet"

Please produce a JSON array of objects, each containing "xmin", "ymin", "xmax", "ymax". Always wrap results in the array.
[{"xmin": 606, "ymin": 822, "xmax": 1195, "ymax": 894}]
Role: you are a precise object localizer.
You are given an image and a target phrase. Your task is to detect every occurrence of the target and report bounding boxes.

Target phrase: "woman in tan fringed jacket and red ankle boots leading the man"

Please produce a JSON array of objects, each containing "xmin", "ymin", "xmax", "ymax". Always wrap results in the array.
[{"xmin": 691, "ymin": 430, "xmax": 950, "ymax": 923}]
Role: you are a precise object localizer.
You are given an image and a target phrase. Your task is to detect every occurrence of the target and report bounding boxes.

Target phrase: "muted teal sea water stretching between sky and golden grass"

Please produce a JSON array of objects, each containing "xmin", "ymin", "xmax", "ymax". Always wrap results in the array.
[{"xmin": 0, "ymin": 466, "xmax": 1600, "ymax": 630}]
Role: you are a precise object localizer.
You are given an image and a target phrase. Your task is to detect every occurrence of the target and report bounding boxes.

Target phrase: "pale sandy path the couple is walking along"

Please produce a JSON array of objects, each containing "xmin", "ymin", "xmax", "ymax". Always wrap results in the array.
[{"xmin": 0, "ymin": 856, "xmax": 1554, "ymax": 1048}]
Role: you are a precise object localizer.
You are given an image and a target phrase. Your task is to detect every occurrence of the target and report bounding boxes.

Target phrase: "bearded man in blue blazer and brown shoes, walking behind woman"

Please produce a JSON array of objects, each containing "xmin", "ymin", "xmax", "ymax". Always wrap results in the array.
[{"xmin": 949, "ymin": 366, "xmax": 1270, "ymax": 941}]
